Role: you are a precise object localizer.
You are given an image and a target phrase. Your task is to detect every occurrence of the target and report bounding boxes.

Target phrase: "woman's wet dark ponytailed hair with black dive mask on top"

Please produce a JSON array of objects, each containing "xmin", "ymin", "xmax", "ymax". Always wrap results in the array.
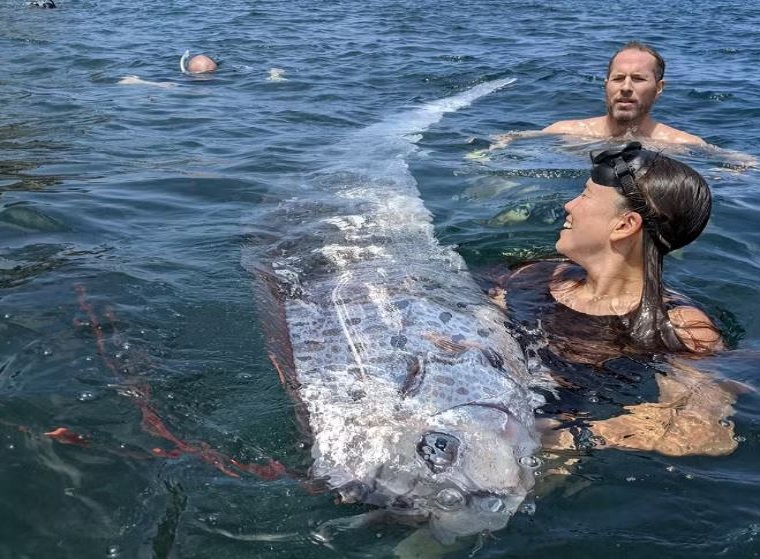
[{"xmin": 592, "ymin": 142, "xmax": 712, "ymax": 351}]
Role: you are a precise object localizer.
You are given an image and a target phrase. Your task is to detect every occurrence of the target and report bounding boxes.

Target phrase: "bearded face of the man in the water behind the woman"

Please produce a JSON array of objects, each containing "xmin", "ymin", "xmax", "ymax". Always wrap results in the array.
[{"xmin": 605, "ymin": 49, "xmax": 664, "ymax": 124}]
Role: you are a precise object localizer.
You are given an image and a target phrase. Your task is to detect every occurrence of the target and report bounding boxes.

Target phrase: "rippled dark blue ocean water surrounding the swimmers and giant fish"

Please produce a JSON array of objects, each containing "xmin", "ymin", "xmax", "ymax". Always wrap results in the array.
[{"xmin": 0, "ymin": 0, "xmax": 760, "ymax": 559}]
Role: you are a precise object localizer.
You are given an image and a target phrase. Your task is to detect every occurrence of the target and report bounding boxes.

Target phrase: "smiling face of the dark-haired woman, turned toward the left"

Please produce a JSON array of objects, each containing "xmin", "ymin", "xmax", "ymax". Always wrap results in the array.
[{"xmin": 556, "ymin": 179, "xmax": 624, "ymax": 265}]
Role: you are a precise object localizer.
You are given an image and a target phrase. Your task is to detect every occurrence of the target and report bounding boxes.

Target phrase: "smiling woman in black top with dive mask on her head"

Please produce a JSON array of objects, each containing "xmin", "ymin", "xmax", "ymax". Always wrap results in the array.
[{"xmin": 496, "ymin": 142, "xmax": 736, "ymax": 455}]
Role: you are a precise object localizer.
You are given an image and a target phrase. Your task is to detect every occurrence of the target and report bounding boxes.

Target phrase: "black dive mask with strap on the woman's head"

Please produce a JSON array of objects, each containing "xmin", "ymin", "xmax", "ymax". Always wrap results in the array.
[{"xmin": 589, "ymin": 142, "xmax": 671, "ymax": 252}]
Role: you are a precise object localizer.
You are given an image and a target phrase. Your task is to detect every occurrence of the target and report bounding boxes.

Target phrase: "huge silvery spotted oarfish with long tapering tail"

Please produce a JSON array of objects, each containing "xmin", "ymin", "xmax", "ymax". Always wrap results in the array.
[{"xmin": 243, "ymin": 79, "xmax": 550, "ymax": 543}]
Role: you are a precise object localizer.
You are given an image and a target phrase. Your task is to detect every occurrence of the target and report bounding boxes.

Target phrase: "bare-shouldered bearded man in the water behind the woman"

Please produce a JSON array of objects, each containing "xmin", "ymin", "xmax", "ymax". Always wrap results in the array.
[{"xmin": 543, "ymin": 41, "xmax": 705, "ymax": 144}]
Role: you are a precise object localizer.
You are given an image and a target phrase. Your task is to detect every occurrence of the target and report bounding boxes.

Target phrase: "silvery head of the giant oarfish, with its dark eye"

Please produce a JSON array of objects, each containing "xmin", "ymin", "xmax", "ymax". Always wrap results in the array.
[{"xmin": 340, "ymin": 404, "xmax": 541, "ymax": 545}]
